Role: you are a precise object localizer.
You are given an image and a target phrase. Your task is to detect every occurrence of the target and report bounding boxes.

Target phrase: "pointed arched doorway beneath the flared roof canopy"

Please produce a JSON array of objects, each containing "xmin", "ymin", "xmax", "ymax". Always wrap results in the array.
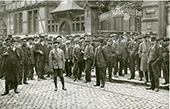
[{"xmin": 59, "ymin": 21, "xmax": 71, "ymax": 35}]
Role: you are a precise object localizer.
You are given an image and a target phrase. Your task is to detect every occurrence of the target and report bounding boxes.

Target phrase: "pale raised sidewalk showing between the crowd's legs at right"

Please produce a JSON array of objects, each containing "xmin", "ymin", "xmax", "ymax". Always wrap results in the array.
[{"xmin": 87, "ymin": 70, "xmax": 169, "ymax": 90}]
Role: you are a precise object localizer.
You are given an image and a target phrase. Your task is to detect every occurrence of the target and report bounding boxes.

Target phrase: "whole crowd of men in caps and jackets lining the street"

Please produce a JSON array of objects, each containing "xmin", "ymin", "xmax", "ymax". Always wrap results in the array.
[{"xmin": 0, "ymin": 33, "xmax": 170, "ymax": 95}]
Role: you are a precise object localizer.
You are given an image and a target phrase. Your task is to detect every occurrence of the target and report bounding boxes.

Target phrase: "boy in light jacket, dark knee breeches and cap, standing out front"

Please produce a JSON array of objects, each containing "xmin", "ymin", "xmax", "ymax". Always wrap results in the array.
[{"xmin": 49, "ymin": 41, "xmax": 66, "ymax": 91}]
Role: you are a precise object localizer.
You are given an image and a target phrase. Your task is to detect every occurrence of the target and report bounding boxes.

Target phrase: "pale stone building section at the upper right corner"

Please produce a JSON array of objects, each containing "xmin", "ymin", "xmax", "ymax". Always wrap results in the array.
[{"xmin": 142, "ymin": 0, "xmax": 170, "ymax": 37}]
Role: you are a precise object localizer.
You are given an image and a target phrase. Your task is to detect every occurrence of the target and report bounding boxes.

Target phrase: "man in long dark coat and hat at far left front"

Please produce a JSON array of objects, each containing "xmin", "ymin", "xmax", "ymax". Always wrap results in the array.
[{"xmin": 2, "ymin": 35, "xmax": 21, "ymax": 96}]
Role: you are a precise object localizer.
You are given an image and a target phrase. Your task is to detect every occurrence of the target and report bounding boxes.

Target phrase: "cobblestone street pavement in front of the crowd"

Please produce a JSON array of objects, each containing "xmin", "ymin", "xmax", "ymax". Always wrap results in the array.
[{"xmin": 0, "ymin": 77, "xmax": 169, "ymax": 109}]
